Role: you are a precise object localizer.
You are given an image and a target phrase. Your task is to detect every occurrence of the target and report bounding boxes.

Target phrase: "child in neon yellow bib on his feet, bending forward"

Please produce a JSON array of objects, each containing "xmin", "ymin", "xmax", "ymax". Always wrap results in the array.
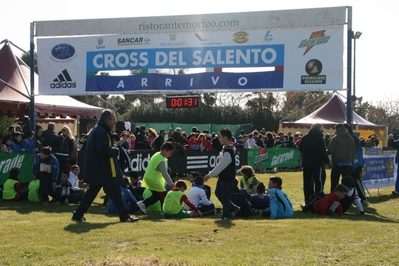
[{"xmin": 137, "ymin": 141, "xmax": 175, "ymax": 214}]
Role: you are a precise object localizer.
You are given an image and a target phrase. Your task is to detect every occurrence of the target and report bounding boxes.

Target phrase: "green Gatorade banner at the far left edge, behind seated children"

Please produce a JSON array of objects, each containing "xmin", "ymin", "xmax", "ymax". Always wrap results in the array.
[{"xmin": 0, "ymin": 152, "xmax": 36, "ymax": 184}]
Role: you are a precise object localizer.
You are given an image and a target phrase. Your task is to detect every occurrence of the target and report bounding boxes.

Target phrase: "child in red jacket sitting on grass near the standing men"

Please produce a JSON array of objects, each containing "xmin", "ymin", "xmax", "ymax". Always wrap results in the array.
[{"xmin": 301, "ymin": 184, "xmax": 348, "ymax": 217}]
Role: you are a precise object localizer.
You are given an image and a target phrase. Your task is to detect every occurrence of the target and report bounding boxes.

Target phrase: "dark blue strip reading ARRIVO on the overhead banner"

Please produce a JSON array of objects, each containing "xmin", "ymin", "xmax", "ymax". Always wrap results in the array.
[{"xmin": 86, "ymin": 71, "xmax": 284, "ymax": 92}]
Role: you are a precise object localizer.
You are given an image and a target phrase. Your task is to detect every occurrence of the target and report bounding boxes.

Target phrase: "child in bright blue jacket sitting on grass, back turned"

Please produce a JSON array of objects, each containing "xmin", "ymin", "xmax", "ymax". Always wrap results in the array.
[{"xmin": 262, "ymin": 176, "xmax": 294, "ymax": 219}]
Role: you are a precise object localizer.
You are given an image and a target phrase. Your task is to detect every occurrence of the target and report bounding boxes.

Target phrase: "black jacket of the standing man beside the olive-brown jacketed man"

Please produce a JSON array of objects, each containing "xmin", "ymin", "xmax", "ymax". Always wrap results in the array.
[{"xmin": 298, "ymin": 128, "xmax": 330, "ymax": 167}]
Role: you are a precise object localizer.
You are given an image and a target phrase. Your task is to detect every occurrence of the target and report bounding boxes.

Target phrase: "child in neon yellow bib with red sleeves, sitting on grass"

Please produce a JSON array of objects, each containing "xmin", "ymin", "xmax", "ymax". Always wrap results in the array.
[{"xmin": 163, "ymin": 180, "xmax": 202, "ymax": 218}]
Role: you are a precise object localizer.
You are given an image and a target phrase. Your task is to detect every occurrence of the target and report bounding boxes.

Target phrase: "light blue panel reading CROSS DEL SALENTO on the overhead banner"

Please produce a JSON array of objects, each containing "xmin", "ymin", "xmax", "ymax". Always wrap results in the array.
[{"xmin": 86, "ymin": 44, "xmax": 285, "ymax": 72}]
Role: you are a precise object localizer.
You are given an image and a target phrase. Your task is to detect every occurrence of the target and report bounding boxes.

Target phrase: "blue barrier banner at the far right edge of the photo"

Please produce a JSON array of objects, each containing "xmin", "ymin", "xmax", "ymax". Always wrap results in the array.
[{"xmin": 363, "ymin": 155, "xmax": 397, "ymax": 188}]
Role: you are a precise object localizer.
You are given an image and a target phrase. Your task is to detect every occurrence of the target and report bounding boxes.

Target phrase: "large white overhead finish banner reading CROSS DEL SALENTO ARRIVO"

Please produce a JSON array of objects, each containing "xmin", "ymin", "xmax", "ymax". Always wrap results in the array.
[{"xmin": 35, "ymin": 7, "xmax": 347, "ymax": 95}]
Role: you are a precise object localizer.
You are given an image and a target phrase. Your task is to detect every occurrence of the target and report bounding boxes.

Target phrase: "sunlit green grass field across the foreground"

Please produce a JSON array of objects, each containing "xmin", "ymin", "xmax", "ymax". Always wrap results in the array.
[{"xmin": 0, "ymin": 171, "xmax": 399, "ymax": 265}]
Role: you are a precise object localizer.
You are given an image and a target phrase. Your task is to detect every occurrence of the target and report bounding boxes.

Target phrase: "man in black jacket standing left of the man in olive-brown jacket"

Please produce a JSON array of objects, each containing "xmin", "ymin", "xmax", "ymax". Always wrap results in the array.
[{"xmin": 299, "ymin": 124, "xmax": 330, "ymax": 204}]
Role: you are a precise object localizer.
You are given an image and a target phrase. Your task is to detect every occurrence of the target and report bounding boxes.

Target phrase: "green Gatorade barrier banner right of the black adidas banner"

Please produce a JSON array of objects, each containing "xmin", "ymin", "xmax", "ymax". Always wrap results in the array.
[{"xmin": 247, "ymin": 148, "xmax": 299, "ymax": 169}]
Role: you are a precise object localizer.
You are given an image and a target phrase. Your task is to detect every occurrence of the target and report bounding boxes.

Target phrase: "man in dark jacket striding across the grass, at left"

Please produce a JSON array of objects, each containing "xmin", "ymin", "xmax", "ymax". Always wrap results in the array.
[{"xmin": 72, "ymin": 109, "xmax": 138, "ymax": 223}]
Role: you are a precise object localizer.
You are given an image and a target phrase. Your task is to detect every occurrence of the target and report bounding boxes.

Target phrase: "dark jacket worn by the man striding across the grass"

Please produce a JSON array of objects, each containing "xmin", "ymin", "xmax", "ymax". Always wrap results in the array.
[{"xmin": 83, "ymin": 121, "xmax": 123, "ymax": 185}]
